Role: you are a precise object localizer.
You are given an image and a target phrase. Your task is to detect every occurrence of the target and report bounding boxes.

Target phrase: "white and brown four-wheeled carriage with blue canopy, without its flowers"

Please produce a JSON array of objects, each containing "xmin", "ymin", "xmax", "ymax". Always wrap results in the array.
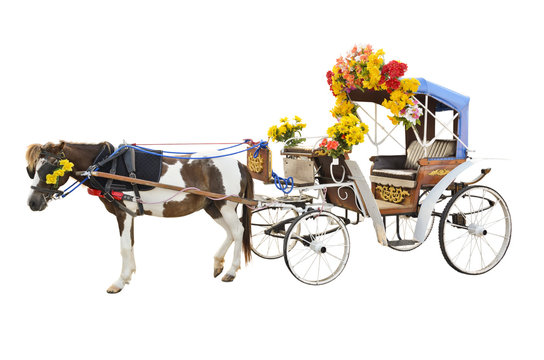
[{"xmin": 248, "ymin": 79, "xmax": 512, "ymax": 285}]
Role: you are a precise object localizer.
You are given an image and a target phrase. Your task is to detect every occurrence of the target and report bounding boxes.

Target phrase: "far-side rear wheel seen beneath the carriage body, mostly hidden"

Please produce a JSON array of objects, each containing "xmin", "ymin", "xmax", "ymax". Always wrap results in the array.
[{"xmin": 384, "ymin": 215, "xmax": 434, "ymax": 251}]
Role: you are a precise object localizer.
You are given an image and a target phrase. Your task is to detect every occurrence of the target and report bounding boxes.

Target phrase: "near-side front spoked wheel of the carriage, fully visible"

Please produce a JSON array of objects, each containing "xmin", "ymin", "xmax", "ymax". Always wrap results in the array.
[{"xmin": 283, "ymin": 210, "xmax": 350, "ymax": 285}]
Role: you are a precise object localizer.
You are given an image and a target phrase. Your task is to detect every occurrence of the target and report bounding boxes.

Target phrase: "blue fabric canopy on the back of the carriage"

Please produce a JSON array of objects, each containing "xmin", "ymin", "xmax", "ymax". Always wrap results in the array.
[{"xmin": 417, "ymin": 78, "xmax": 470, "ymax": 158}]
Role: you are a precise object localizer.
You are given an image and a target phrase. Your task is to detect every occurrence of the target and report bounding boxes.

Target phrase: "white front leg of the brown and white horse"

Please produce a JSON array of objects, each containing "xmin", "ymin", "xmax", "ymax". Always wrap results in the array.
[{"xmin": 107, "ymin": 211, "xmax": 136, "ymax": 294}]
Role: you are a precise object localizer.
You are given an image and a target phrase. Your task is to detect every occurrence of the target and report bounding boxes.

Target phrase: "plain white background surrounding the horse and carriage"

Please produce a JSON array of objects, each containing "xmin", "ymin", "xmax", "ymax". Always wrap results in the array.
[{"xmin": 0, "ymin": 1, "xmax": 544, "ymax": 359}]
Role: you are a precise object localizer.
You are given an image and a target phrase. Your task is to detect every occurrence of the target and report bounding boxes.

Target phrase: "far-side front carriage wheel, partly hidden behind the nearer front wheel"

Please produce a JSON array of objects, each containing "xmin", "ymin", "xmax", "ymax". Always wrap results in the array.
[{"xmin": 251, "ymin": 207, "xmax": 298, "ymax": 259}]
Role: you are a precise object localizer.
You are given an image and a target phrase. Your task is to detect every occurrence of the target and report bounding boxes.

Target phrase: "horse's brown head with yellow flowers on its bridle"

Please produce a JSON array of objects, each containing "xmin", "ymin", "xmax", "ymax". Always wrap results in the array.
[{"xmin": 26, "ymin": 142, "xmax": 74, "ymax": 211}]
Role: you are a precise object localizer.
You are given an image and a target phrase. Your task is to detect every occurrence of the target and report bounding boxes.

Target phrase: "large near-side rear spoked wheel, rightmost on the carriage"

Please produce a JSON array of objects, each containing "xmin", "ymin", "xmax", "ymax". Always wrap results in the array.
[{"xmin": 439, "ymin": 186, "xmax": 512, "ymax": 275}]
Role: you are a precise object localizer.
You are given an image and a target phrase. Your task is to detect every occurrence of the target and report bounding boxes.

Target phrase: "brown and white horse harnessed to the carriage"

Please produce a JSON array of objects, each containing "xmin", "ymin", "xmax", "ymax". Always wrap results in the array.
[{"xmin": 26, "ymin": 141, "xmax": 253, "ymax": 294}]
